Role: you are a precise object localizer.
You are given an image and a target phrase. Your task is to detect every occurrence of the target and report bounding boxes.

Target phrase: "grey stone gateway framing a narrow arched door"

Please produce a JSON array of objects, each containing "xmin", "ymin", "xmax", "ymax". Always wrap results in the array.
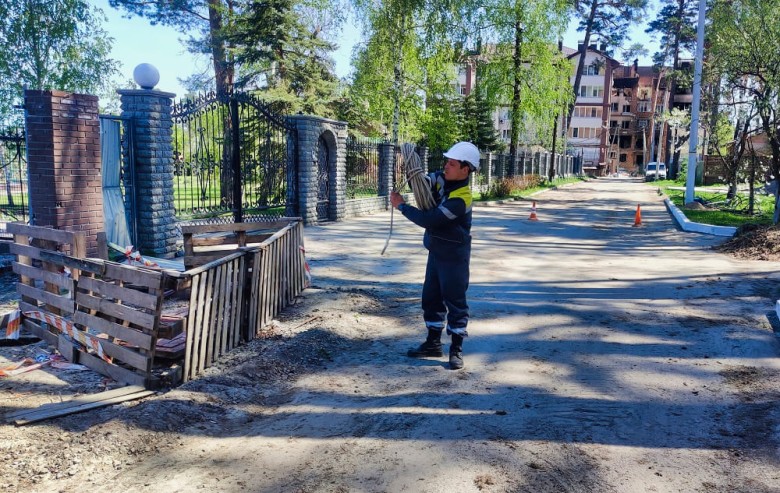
[{"xmin": 287, "ymin": 115, "xmax": 347, "ymax": 224}]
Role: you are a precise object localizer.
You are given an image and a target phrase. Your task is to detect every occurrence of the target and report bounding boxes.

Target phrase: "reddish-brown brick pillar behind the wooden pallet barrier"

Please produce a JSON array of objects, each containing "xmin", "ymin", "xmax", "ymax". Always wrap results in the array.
[{"xmin": 24, "ymin": 91, "xmax": 104, "ymax": 256}]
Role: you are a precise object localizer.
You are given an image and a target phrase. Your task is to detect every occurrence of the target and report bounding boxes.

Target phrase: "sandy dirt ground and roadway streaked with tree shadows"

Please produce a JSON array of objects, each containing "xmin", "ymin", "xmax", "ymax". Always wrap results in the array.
[{"xmin": 0, "ymin": 179, "xmax": 780, "ymax": 492}]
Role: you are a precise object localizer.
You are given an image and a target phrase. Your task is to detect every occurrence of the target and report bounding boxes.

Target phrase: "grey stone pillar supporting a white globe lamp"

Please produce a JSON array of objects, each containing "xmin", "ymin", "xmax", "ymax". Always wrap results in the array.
[{"xmin": 117, "ymin": 89, "xmax": 178, "ymax": 258}]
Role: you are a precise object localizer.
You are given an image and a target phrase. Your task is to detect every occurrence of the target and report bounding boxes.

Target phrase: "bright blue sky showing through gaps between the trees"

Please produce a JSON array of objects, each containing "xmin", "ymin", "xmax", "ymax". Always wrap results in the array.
[{"xmin": 94, "ymin": 0, "xmax": 655, "ymax": 96}]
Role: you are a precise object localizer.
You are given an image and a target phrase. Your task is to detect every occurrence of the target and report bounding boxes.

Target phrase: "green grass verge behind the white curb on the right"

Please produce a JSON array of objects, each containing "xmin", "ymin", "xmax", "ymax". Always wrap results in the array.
[{"xmin": 660, "ymin": 180, "xmax": 774, "ymax": 227}]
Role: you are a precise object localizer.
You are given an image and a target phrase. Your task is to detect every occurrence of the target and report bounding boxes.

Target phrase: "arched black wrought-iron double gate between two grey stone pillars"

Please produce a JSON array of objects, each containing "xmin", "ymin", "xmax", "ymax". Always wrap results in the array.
[{"xmin": 171, "ymin": 93, "xmax": 298, "ymax": 222}]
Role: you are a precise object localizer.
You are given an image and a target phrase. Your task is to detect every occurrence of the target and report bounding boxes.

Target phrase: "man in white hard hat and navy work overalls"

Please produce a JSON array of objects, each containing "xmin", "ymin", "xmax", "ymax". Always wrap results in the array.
[{"xmin": 390, "ymin": 142, "xmax": 479, "ymax": 370}]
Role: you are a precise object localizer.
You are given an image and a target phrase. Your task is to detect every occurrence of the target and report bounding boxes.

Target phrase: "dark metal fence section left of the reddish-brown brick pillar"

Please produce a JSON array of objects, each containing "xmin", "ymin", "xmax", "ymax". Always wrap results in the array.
[{"xmin": 0, "ymin": 127, "xmax": 29, "ymax": 222}]
